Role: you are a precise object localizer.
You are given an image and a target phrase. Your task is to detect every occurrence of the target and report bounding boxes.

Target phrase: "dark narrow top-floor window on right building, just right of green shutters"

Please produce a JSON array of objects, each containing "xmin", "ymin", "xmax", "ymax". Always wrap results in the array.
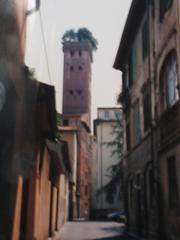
[{"xmin": 142, "ymin": 19, "xmax": 149, "ymax": 60}]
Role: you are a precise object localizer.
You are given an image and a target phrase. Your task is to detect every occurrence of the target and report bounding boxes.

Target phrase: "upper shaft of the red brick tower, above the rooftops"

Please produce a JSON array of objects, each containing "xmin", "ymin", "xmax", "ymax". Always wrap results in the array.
[{"xmin": 63, "ymin": 42, "xmax": 92, "ymax": 127}]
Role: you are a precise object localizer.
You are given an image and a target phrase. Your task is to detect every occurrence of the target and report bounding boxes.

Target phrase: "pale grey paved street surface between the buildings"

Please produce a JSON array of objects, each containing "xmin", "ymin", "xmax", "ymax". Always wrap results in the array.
[{"xmin": 55, "ymin": 221, "xmax": 137, "ymax": 240}]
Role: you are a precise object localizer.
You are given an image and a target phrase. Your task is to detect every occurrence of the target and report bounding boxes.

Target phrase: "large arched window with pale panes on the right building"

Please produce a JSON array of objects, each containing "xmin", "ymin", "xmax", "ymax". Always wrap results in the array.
[{"xmin": 159, "ymin": 51, "xmax": 179, "ymax": 111}]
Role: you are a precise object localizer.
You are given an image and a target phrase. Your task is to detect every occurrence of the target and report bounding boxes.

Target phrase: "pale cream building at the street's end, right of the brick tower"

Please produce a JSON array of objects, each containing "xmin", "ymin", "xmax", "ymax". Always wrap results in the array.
[{"xmin": 93, "ymin": 108, "xmax": 123, "ymax": 217}]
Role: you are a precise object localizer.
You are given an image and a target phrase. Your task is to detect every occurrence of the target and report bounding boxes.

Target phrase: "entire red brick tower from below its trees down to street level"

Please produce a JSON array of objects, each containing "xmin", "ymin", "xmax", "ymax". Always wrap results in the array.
[{"xmin": 63, "ymin": 42, "xmax": 92, "ymax": 219}]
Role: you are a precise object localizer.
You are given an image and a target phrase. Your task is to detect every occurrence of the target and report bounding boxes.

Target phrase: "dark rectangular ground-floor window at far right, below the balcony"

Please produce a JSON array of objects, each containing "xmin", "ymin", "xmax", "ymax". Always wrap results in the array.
[{"xmin": 167, "ymin": 156, "xmax": 178, "ymax": 208}]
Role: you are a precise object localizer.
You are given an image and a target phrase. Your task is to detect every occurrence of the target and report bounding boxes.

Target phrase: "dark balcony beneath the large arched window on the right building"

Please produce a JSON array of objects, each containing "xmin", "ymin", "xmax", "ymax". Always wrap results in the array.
[{"xmin": 159, "ymin": 101, "xmax": 180, "ymax": 147}]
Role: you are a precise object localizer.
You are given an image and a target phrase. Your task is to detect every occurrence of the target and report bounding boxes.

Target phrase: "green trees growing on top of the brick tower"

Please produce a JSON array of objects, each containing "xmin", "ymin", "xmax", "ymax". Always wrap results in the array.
[{"xmin": 62, "ymin": 27, "xmax": 98, "ymax": 50}]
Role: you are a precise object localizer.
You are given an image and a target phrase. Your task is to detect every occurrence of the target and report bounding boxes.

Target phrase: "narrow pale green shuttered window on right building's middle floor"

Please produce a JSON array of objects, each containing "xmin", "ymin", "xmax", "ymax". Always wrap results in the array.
[{"xmin": 133, "ymin": 102, "xmax": 141, "ymax": 144}]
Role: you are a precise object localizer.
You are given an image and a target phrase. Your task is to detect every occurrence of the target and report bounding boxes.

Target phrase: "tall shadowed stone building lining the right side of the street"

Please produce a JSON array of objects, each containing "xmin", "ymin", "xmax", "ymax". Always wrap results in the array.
[{"xmin": 114, "ymin": 0, "xmax": 180, "ymax": 240}]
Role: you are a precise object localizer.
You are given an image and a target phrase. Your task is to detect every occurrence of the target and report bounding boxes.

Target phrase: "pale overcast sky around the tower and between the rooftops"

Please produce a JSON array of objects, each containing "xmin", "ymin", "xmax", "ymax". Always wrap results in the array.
[{"xmin": 26, "ymin": 0, "xmax": 132, "ymax": 118}]
